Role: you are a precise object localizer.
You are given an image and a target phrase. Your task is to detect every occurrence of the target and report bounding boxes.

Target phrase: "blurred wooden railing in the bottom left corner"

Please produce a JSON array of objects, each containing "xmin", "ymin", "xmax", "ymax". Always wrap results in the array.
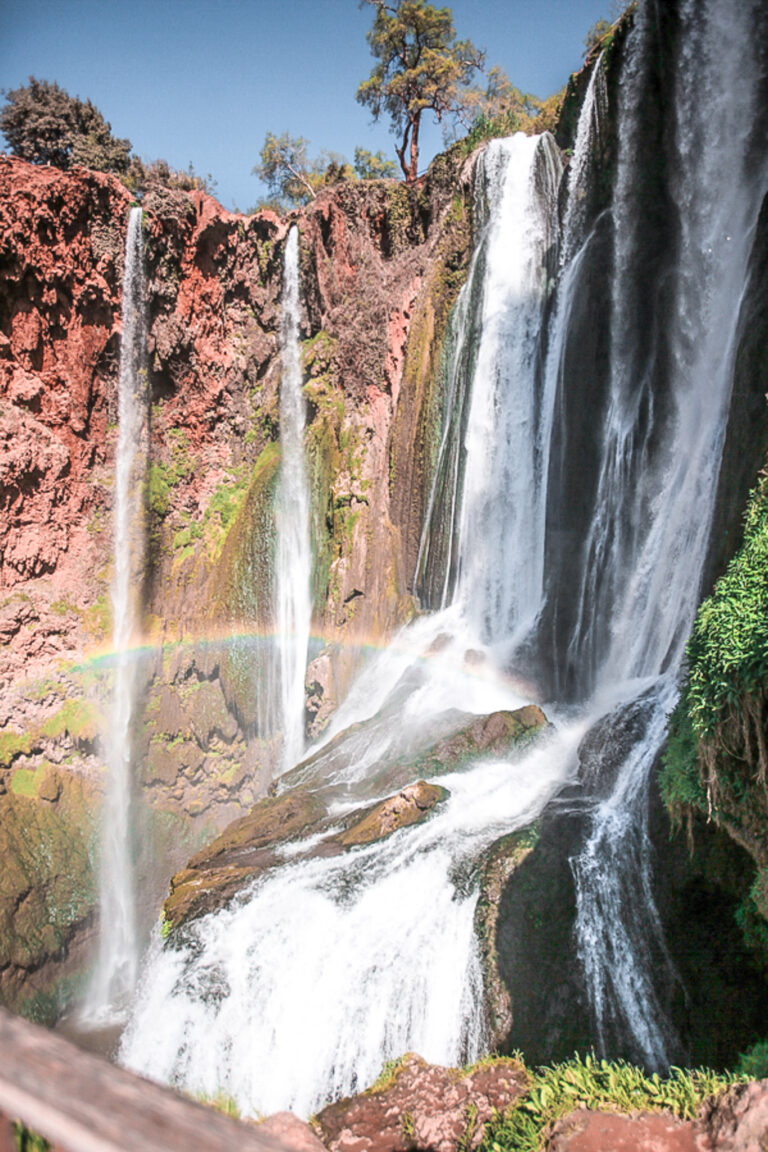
[{"xmin": 0, "ymin": 1008, "xmax": 295, "ymax": 1152}]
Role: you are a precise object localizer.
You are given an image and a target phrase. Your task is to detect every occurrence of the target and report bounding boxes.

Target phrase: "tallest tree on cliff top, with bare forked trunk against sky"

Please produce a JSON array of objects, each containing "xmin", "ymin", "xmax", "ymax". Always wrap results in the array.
[{"xmin": 357, "ymin": 0, "xmax": 484, "ymax": 184}]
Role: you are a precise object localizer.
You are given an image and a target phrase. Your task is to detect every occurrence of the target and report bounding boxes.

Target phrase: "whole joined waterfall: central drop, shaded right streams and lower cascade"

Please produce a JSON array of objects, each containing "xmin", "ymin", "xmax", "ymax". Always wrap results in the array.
[{"xmin": 121, "ymin": 0, "xmax": 768, "ymax": 1115}]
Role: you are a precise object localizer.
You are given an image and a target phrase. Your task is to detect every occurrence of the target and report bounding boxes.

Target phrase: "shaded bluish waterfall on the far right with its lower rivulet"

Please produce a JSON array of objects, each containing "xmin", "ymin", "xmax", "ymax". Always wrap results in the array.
[{"xmin": 573, "ymin": 0, "xmax": 767, "ymax": 1067}]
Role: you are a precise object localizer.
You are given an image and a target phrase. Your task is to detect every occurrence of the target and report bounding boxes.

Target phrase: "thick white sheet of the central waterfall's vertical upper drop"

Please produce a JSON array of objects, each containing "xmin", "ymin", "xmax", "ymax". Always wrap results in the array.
[{"xmin": 455, "ymin": 135, "xmax": 562, "ymax": 657}]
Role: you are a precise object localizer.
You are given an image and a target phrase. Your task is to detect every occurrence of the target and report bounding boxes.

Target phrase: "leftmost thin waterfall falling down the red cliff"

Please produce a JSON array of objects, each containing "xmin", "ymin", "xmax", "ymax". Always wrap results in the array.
[{"xmin": 83, "ymin": 207, "xmax": 146, "ymax": 1023}]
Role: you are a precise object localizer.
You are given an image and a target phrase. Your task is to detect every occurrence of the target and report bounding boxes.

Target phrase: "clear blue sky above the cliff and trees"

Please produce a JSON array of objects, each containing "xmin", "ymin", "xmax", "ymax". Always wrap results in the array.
[{"xmin": 0, "ymin": 0, "xmax": 611, "ymax": 210}]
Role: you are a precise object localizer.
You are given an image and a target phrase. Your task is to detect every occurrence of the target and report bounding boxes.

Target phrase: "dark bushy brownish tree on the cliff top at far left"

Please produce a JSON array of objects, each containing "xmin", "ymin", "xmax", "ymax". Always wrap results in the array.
[{"xmin": 0, "ymin": 76, "xmax": 130, "ymax": 173}]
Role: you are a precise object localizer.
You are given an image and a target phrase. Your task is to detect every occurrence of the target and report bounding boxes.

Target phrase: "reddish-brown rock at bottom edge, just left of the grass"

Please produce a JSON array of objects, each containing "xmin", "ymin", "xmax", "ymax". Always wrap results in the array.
[{"xmin": 314, "ymin": 1053, "xmax": 527, "ymax": 1152}]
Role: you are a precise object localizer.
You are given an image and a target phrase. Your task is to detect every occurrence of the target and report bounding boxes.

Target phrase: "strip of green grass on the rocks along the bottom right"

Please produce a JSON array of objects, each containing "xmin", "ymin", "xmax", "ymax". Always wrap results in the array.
[{"xmin": 480, "ymin": 1055, "xmax": 744, "ymax": 1152}]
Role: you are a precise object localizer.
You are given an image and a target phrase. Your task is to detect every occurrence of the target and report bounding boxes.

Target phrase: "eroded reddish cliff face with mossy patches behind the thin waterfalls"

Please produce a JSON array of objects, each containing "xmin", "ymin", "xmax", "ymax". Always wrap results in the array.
[{"xmin": 0, "ymin": 141, "xmax": 472, "ymax": 1010}]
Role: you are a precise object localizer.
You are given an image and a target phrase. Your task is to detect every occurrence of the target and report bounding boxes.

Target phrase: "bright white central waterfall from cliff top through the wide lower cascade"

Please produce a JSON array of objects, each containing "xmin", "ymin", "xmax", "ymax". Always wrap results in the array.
[{"xmin": 121, "ymin": 136, "xmax": 571, "ymax": 1114}]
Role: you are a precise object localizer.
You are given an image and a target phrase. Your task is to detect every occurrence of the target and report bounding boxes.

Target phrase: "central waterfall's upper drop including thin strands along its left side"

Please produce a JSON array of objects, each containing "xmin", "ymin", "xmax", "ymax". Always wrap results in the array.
[{"xmin": 417, "ymin": 135, "xmax": 562, "ymax": 654}]
